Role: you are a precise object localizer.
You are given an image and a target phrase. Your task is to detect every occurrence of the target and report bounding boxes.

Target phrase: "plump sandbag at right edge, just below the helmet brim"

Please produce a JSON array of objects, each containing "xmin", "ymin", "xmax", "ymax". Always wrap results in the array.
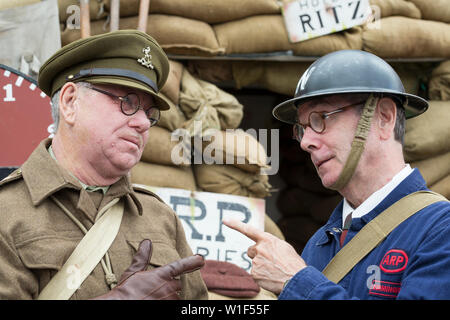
[{"xmin": 403, "ymin": 101, "xmax": 450, "ymax": 162}]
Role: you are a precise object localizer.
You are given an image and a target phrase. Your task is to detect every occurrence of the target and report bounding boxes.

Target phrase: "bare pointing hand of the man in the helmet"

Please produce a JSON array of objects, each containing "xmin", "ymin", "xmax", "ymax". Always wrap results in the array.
[{"xmin": 222, "ymin": 219, "xmax": 306, "ymax": 294}]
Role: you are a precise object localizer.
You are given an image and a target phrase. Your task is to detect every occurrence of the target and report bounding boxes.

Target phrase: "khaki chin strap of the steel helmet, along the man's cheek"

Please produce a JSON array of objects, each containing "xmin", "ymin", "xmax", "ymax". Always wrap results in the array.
[{"xmin": 329, "ymin": 94, "xmax": 379, "ymax": 190}]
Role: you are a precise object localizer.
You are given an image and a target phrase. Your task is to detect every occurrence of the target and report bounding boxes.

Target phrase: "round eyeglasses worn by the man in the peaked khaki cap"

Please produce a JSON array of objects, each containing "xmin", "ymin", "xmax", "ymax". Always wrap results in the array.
[{"xmin": 90, "ymin": 87, "xmax": 161, "ymax": 127}]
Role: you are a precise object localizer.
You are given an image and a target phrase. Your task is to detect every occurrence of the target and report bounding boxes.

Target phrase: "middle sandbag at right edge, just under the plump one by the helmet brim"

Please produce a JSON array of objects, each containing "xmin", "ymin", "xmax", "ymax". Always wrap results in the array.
[{"xmin": 411, "ymin": 152, "xmax": 450, "ymax": 186}]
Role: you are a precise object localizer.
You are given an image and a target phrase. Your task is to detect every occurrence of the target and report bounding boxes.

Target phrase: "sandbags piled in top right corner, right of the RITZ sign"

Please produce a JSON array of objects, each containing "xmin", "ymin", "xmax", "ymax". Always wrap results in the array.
[{"xmin": 362, "ymin": 0, "xmax": 450, "ymax": 58}]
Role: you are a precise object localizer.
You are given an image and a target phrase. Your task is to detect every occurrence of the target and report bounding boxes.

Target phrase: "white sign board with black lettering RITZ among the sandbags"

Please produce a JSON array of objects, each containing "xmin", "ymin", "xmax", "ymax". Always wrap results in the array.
[{"xmin": 282, "ymin": 0, "xmax": 372, "ymax": 43}]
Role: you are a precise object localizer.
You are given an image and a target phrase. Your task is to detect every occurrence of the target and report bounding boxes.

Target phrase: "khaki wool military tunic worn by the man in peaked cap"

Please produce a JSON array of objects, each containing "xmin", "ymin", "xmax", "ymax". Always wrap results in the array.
[{"xmin": 0, "ymin": 139, "xmax": 208, "ymax": 299}]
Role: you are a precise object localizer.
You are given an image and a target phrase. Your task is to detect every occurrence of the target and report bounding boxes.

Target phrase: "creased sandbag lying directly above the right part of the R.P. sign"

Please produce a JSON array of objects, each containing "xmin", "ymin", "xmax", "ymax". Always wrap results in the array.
[{"xmin": 194, "ymin": 164, "xmax": 271, "ymax": 198}]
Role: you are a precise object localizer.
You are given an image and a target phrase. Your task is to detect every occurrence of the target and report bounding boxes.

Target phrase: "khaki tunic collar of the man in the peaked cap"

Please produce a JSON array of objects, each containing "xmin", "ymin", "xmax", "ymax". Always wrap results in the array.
[{"xmin": 21, "ymin": 139, "xmax": 142, "ymax": 215}]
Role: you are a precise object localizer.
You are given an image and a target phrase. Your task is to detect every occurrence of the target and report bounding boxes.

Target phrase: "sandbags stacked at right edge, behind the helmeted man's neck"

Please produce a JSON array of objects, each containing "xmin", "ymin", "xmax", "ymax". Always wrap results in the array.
[{"xmin": 403, "ymin": 100, "xmax": 450, "ymax": 198}]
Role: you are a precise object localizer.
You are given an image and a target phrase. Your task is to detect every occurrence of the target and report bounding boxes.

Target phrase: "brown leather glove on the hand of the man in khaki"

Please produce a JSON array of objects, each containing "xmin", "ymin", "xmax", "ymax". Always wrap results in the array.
[{"xmin": 94, "ymin": 239, "xmax": 205, "ymax": 300}]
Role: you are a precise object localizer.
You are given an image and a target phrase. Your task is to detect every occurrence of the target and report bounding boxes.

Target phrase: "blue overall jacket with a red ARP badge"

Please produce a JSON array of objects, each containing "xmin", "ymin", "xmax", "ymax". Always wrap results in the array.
[{"xmin": 279, "ymin": 169, "xmax": 450, "ymax": 300}]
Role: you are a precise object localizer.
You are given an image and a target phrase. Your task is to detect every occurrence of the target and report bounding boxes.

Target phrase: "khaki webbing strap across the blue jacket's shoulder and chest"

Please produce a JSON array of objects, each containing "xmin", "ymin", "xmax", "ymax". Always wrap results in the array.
[{"xmin": 322, "ymin": 191, "xmax": 448, "ymax": 283}]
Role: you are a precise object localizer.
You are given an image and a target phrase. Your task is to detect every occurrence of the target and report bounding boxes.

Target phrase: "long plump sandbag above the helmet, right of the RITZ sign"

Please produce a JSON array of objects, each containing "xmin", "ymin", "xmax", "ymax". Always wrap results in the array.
[{"xmin": 362, "ymin": 17, "xmax": 450, "ymax": 58}]
